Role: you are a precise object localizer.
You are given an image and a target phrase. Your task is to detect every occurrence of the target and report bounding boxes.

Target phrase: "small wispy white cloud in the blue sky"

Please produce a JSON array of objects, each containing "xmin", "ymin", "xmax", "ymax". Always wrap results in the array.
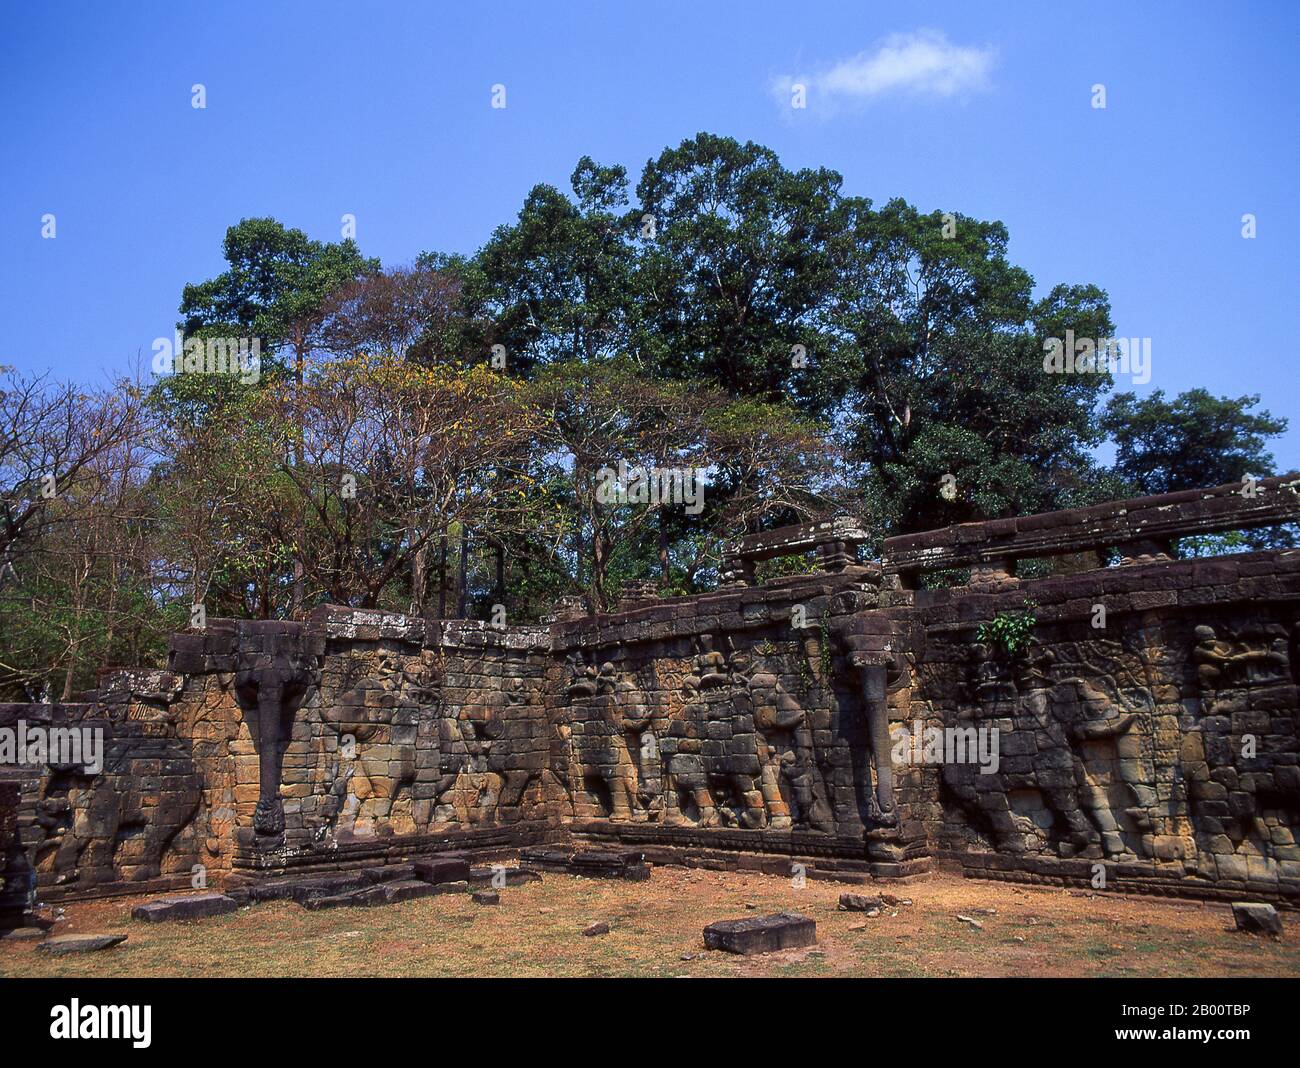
[{"xmin": 774, "ymin": 30, "xmax": 996, "ymax": 109}]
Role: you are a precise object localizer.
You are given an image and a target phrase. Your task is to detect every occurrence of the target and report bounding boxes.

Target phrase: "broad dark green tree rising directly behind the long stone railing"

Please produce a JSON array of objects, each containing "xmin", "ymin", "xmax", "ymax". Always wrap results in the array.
[{"xmin": 824, "ymin": 200, "xmax": 1112, "ymax": 531}]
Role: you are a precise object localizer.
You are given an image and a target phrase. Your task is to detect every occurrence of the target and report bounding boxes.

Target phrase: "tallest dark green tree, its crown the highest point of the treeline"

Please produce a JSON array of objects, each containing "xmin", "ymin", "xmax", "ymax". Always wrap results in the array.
[{"xmin": 634, "ymin": 134, "xmax": 848, "ymax": 412}]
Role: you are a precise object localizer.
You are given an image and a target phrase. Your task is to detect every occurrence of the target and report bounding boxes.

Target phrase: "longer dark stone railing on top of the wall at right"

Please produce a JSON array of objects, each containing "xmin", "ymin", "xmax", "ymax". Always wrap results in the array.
[{"xmin": 878, "ymin": 474, "xmax": 1300, "ymax": 589}]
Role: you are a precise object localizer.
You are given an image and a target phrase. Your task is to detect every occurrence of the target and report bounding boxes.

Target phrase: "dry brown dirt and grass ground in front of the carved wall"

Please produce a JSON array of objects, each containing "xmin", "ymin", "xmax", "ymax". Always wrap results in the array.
[{"xmin": 0, "ymin": 868, "xmax": 1300, "ymax": 977}]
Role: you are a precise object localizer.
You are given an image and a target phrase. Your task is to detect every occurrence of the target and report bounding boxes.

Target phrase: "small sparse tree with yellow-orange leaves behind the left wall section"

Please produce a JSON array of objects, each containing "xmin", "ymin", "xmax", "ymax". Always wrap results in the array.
[{"xmin": 261, "ymin": 353, "xmax": 534, "ymax": 611}]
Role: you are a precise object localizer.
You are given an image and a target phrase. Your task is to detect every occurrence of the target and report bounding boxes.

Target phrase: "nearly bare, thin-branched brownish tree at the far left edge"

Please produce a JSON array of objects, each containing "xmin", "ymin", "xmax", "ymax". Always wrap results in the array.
[{"xmin": 0, "ymin": 375, "xmax": 177, "ymax": 700}]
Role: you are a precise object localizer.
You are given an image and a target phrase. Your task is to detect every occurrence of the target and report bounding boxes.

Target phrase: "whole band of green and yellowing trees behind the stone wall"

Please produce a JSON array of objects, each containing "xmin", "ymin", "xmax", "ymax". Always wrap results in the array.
[{"xmin": 0, "ymin": 134, "xmax": 1286, "ymax": 696}]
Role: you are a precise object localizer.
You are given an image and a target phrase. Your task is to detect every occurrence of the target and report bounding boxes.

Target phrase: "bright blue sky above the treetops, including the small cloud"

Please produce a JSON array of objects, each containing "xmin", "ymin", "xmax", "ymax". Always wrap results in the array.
[{"xmin": 0, "ymin": 0, "xmax": 1300, "ymax": 469}]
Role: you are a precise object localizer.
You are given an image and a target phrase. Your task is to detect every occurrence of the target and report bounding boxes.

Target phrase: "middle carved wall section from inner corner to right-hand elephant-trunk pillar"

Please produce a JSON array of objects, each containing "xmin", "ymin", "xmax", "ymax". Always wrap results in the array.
[{"xmin": 547, "ymin": 573, "xmax": 924, "ymax": 874}]
